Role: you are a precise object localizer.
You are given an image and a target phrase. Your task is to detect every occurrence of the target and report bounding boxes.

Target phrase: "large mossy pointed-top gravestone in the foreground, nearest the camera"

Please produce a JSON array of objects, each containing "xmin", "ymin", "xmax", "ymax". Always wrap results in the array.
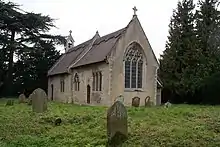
[{"xmin": 107, "ymin": 101, "xmax": 128, "ymax": 146}]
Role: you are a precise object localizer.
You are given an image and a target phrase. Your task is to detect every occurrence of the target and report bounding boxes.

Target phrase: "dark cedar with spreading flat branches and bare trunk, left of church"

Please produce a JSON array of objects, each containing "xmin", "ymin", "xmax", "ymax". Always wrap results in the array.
[{"xmin": 0, "ymin": 0, "xmax": 64, "ymax": 95}]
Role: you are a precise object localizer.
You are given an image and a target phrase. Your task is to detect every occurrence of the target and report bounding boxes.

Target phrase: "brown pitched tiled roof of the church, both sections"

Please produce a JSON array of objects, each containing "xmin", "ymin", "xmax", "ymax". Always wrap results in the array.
[{"xmin": 48, "ymin": 28, "xmax": 126, "ymax": 76}]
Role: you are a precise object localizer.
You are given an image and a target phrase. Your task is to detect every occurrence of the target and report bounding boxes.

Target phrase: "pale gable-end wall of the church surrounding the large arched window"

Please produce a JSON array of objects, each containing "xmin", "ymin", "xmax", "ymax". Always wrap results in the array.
[{"xmin": 110, "ymin": 15, "xmax": 159, "ymax": 106}]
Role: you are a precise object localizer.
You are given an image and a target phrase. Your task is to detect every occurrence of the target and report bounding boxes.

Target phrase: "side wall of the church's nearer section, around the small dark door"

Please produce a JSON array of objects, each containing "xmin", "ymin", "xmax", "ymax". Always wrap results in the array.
[{"xmin": 72, "ymin": 62, "xmax": 110, "ymax": 105}]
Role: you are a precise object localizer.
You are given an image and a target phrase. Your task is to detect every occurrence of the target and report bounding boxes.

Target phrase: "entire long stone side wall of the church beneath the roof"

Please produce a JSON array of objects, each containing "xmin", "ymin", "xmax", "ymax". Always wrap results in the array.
[{"xmin": 48, "ymin": 62, "xmax": 111, "ymax": 105}]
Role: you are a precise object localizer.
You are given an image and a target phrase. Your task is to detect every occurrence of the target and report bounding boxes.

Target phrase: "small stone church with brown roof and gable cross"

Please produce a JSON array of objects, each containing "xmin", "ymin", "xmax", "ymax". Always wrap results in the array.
[{"xmin": 48, "ymin": 8, "xmax": 162, "ymax": 106}]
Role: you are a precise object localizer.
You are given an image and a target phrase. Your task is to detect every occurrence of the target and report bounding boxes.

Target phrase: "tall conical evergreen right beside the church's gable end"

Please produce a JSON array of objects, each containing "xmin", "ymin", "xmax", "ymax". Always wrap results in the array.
[{"xmin": 160, "ymin": 0, "xmax": 196, "ymax": 102}]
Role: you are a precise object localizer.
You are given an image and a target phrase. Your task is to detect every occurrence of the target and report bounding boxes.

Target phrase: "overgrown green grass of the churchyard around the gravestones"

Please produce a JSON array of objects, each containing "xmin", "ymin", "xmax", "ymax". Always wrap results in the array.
[{"xmin": 0, "ymin": 99, "xmax": 220, "ymax": 147}]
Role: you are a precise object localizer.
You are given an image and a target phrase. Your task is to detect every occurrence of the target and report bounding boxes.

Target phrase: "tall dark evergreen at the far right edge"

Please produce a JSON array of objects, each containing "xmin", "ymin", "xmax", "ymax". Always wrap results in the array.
[{"xmin": 195, "ymin": 0, "xmax": 220, "ymax": 104}]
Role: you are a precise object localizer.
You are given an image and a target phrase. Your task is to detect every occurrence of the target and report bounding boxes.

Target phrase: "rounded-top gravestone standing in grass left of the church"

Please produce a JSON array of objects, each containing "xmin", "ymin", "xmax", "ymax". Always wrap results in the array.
[{"xmin": 29, "ymin": 88, "xmax": 47, "ymax": 113}]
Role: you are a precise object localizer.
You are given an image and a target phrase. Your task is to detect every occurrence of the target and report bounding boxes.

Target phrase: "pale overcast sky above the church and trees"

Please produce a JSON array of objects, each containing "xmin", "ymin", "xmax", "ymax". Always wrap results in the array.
[{"xmin": 10, "ymin": 0, "xmax": 193, "ymax": 58}]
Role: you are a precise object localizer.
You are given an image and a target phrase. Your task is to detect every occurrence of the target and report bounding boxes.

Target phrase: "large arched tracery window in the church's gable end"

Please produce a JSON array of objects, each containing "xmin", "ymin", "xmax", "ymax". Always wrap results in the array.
[{"xmin": 124, "ymin": 43, "xmax": 143, "ymax": 89}]
